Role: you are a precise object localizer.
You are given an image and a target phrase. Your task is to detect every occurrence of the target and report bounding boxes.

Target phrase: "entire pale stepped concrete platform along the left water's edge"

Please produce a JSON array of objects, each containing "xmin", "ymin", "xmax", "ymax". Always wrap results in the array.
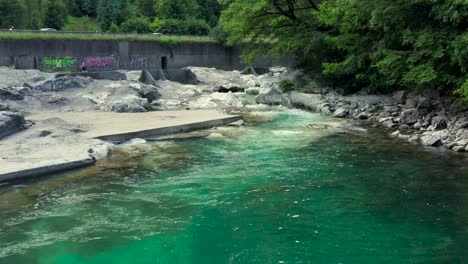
[{"xmin": 0, "ymin": 110, "xmax": 242, "ymax": 182}]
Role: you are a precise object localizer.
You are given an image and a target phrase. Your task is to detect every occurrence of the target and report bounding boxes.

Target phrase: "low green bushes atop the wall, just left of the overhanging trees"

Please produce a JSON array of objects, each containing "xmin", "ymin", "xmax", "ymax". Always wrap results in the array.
[{"xmin": 153, "ymin": 19, "xmax": 210, "ymax": 35}]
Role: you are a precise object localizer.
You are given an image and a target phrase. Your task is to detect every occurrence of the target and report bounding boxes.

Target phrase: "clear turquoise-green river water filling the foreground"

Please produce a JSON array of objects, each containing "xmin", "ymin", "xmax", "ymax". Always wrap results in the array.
[{"xmin": 0, "ymin": 112, "xmax": 468, "ymax": 264}]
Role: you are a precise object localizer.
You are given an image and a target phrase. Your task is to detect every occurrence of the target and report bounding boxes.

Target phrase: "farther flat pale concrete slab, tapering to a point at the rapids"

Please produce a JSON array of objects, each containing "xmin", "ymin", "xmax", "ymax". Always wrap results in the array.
[{"xmin": 28, "ymin": 110, "xmax": 242, "ymax": 142}]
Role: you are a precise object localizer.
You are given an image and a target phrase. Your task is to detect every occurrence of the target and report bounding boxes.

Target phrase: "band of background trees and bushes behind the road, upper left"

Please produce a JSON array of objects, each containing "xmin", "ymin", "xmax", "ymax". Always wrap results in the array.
[{"xmin": 0, "ymin": 0, "xmax": 223, "ymax": 35}]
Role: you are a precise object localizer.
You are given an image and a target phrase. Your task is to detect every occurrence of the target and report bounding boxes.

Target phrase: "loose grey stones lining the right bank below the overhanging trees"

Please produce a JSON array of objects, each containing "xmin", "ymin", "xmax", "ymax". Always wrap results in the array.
[{"xmin": 256, "ymin": 84, "xmax": 468, "ymax": 152}]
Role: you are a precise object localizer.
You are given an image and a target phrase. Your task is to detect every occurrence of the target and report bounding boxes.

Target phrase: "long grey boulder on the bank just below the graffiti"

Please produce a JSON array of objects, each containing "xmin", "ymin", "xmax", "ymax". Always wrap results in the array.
[{"xmin": 35, "ymin": 75, "xmax": 93, "ymax": 92}]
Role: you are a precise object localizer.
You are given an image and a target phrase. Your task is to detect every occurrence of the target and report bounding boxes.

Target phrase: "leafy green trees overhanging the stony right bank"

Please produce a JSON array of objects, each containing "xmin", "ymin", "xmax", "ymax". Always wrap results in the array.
[{"xmin": 221, "ymin": 0, "xmax": 468, "ymax": 100}]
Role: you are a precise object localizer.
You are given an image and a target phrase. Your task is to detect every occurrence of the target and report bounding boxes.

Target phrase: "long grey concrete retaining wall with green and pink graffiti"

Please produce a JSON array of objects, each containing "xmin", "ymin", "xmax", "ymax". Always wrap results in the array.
[{"xmin": 0, "ymin": 40, "xmax": 293, "ymax": 71}]
